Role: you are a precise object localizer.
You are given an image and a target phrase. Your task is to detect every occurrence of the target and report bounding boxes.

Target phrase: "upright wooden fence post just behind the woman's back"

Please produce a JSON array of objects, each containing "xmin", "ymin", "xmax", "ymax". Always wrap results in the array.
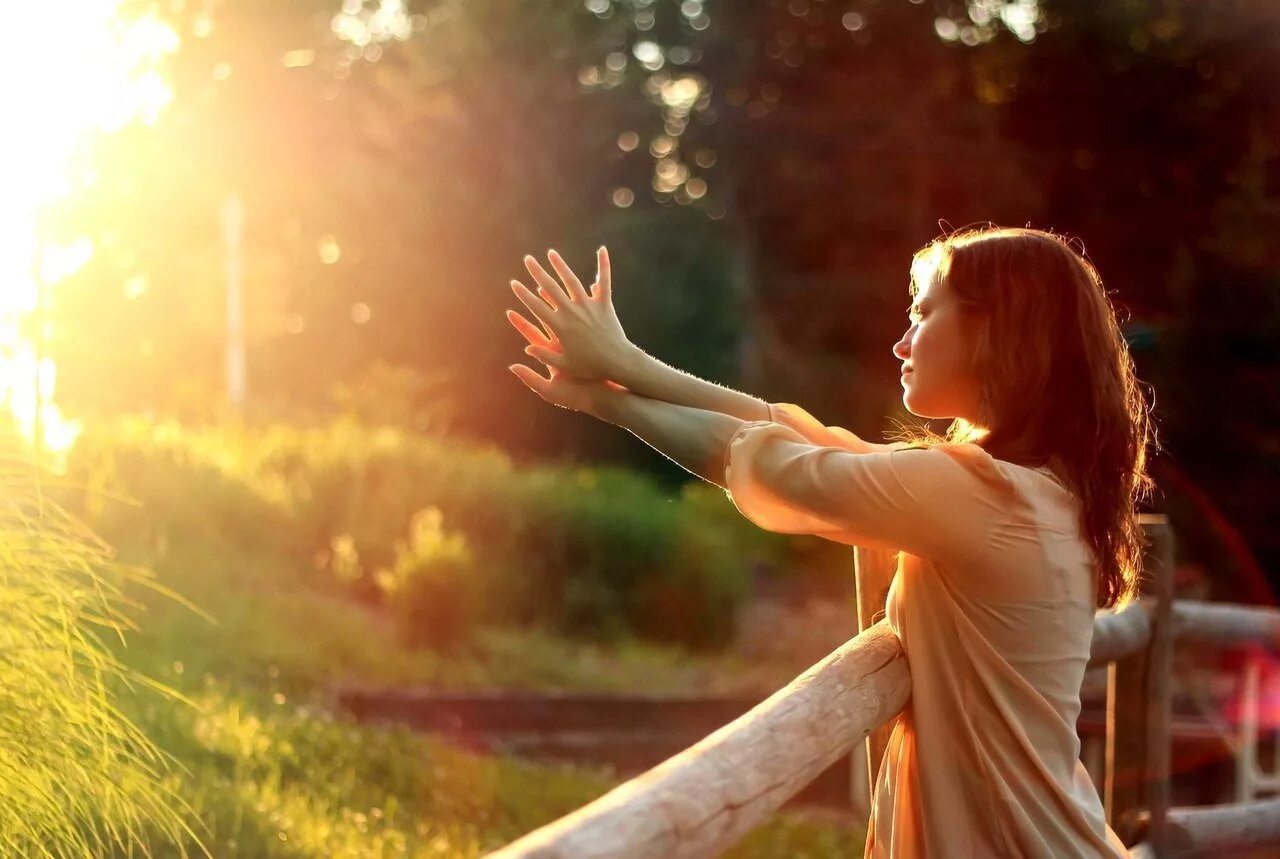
[{"xmin": 1105, "ymin": 513, "xmax": 1174, "ymax": 855}]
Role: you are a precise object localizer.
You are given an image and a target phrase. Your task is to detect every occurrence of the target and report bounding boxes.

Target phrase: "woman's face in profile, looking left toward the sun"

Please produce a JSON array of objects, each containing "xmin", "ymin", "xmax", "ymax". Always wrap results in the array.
[{"xmin": 893, "ymin": 278, "xmax": 979, "ymax": 424}]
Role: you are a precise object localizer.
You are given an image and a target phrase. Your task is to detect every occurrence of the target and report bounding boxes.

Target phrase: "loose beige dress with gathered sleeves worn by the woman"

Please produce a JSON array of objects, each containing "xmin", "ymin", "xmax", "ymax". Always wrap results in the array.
[{"xmin": 724, "ymin": 403, "xmax": 1129, "ymax": 859}]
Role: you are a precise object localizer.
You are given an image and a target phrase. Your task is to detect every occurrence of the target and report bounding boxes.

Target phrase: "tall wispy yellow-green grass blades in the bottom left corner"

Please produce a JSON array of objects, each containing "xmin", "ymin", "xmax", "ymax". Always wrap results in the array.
[{"xmin": 0, "ymin": 437, "xmax": 201, "ymax": 856}]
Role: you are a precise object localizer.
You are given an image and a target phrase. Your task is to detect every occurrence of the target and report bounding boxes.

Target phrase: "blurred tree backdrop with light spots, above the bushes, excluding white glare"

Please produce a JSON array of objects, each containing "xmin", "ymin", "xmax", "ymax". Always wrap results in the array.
[{"xmin": 37, "ymin": 0, "xmax": 1280, "ymax": 599}]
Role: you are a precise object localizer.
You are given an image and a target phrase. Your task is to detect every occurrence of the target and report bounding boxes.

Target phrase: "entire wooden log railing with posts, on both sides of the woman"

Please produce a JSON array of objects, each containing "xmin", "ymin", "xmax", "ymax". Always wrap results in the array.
[{"xmin": 490, "ymin": 516, "xmax": 1280, "ymax": 859}]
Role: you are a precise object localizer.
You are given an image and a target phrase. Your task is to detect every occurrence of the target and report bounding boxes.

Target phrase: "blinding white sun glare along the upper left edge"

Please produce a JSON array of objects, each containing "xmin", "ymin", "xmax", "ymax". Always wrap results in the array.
[{"xmin": 0, "ymin": 0, "xmax": 179, "ymax": 463}]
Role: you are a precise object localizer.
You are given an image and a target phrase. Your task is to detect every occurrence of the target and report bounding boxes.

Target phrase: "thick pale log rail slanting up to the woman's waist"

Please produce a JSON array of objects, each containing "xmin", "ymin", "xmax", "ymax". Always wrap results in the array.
[{"xmin": 490, "ymin": 623, "xmax": 911, "ymax": 859}]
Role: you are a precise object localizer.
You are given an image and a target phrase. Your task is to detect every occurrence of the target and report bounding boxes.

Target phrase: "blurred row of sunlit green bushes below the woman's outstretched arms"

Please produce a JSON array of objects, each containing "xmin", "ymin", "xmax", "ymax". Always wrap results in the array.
[{"xmin": 62, "ymin": 420, "xmax": 783, "ymax": 646}]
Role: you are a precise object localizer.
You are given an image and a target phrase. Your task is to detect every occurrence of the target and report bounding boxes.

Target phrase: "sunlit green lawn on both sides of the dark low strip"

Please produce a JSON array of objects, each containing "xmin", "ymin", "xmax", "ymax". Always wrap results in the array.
[{"xmin": 37, "ymin": 417, "xmax": 864, "ymax": 859}]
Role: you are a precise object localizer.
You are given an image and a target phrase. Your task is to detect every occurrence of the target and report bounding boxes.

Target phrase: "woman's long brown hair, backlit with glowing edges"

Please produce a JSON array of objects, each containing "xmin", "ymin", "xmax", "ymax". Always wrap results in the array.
[{"xmin": 910, "ymin": 225, "xmax": 1158, "ymax": 608}]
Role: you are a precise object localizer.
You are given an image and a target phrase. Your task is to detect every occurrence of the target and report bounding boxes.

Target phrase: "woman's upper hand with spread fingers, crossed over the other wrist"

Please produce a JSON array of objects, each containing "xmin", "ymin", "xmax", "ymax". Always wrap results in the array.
[{"xmin": 507, "ymin": 247, "xmax": 634, "ymax": 379}]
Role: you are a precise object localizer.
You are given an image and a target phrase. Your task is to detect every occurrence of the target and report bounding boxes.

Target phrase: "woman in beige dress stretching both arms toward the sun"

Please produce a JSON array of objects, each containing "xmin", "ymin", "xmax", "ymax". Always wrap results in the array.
[{"xmin": 508, "ymin": 227, "xmax": 1155, "ymax": 859}]
